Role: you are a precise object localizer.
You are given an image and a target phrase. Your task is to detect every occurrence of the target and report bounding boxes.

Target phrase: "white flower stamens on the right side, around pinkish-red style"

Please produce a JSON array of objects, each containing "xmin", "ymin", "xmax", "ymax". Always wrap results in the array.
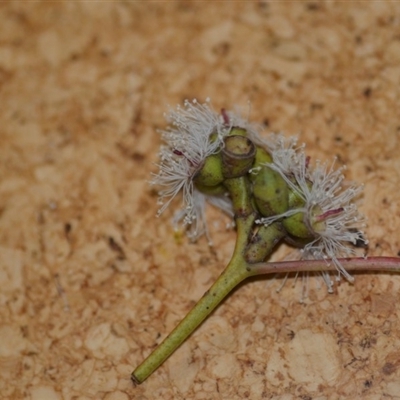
[{"xmin": 257, "ymin": 142, "xmax": 368, "ymax": 291}]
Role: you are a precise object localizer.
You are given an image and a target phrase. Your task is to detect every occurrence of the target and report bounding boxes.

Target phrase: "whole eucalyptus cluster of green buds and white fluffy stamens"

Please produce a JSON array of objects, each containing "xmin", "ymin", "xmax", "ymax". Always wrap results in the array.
[{"xmin": 153, "ymin": 100, "xmax": 367, "ymax": 284}]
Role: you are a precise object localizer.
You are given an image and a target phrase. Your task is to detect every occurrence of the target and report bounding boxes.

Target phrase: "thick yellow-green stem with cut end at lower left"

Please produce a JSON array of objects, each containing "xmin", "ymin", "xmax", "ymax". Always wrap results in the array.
[{"xmin": 132, "ymin": 216, "xmax": 254, "ymax": 384}]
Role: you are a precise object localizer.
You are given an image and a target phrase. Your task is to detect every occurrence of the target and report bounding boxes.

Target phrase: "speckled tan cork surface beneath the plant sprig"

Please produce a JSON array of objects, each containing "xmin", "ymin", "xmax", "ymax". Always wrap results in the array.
[{"xmin": 0, "ymin": 1, "xmax": 400, "ymax": 400}]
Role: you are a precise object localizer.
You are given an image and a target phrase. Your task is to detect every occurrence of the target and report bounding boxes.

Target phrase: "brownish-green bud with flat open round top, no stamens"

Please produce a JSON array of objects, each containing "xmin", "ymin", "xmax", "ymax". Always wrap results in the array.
[{"xmin": 221, "ymin": 135, "xmax": 256, "ymax": 179}]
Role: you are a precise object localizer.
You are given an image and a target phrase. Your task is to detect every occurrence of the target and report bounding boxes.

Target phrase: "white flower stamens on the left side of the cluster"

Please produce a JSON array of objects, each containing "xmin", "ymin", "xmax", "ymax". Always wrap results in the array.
[{"xmin": 152, "ymin": 100, "xmax": 233, "ymax": 239}]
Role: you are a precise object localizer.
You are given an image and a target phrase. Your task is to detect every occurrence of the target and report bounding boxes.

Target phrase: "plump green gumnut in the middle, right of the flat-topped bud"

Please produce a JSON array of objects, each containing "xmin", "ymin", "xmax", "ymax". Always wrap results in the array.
[{"xmin": 250, "ymin": 166, "xmax": 289, "ymax": 217}]
